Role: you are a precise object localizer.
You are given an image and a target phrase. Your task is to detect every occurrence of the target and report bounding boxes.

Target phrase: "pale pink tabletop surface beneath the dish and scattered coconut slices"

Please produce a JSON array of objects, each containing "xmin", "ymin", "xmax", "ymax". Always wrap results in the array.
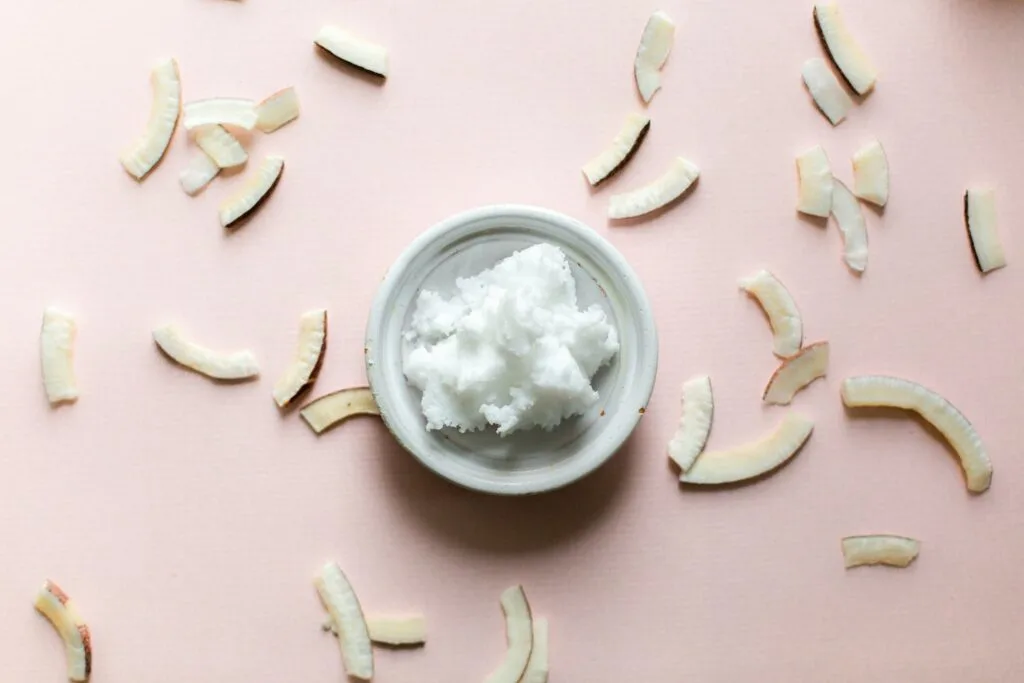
[{"xmin": 0, "ymin": 0, "xmax": 1024, "ymax": 683}]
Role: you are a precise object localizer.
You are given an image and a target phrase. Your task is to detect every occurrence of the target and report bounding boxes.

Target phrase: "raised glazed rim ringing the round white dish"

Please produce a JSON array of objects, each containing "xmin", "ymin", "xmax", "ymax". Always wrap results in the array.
[{"xmin": 365, "ymin": 204, "xmax": 658, "ymax": 496}]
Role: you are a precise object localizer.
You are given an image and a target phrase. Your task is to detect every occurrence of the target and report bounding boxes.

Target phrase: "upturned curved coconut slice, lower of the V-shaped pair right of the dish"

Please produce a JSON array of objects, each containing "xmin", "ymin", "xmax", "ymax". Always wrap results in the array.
[{"xmin": 680, "ymin": 413, "xmax": 814, "ymax": 484}]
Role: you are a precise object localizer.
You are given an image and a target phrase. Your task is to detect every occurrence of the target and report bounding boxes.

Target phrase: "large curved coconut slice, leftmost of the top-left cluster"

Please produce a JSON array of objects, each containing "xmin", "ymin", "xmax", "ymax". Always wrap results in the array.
[{"xmin": 121, "ymin": 59, "xmax": 181, "ymax": 180}]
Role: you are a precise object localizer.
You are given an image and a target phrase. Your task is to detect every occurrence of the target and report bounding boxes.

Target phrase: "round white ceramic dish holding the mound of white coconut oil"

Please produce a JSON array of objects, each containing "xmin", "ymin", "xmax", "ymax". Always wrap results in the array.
[{"xmin": 366, "ymin": 205, "xmax": 657, "ymax": 495}]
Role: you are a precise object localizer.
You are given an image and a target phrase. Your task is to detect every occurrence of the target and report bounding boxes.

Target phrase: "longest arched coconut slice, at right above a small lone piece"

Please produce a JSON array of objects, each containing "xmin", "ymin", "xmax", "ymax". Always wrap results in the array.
[{"xmin": 842, "ymin": 375, "xmax": 992, "ymax": 494}]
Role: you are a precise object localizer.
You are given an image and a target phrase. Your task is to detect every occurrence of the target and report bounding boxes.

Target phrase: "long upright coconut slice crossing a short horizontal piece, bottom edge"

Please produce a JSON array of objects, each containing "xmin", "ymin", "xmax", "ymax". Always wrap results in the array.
[{"xmin": 313, "ymin": 562, "xmax": 374, "ymax": 681}]
